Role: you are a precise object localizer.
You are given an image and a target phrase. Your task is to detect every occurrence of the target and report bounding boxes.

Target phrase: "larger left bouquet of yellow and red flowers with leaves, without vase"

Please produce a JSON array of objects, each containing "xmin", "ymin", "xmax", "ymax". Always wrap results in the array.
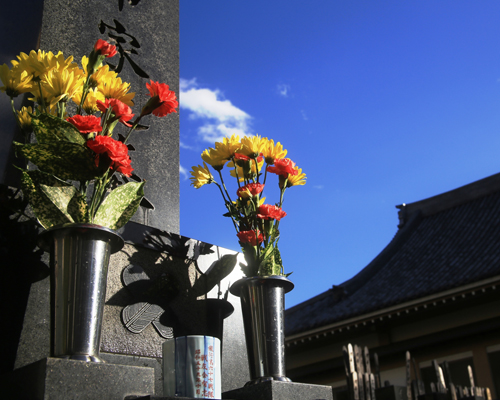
[{"xmin": 0, "ymin": 39, "xmax": 178, "ymax": 230}]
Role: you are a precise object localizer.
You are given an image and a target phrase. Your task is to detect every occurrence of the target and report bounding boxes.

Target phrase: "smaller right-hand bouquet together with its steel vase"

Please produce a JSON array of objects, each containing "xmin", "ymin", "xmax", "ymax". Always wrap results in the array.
[{"xmin": 191, "ymin": 135, "xmax": 306, "ymax": 384}]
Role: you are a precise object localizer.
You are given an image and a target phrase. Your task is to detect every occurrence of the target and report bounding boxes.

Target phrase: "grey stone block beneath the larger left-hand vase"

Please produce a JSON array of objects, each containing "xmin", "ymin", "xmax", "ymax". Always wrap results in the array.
[{"xmin": 0, "ymin": 358, "xmax": 154, "ymax": 400}]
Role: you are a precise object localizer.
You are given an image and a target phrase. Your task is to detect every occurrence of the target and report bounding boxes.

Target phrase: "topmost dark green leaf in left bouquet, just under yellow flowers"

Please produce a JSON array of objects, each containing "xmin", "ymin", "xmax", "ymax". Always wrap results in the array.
[{"xmin": 31, "ymin": 114, "xmax": 86, "ymax": 145}]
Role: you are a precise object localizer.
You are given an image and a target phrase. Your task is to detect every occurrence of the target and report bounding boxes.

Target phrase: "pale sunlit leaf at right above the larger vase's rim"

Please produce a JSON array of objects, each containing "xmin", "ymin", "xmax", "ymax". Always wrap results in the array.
[{"xmin": 94, "ymin": 182, "xmax": 144, "ymax": 229}]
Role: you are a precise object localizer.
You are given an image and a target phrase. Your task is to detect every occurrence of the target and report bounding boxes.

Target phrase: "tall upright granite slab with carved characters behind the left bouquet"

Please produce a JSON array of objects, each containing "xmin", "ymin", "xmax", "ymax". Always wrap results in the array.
[{"xmin": 0, "ymin": 0, "xmax": 179, "ymax": 233}]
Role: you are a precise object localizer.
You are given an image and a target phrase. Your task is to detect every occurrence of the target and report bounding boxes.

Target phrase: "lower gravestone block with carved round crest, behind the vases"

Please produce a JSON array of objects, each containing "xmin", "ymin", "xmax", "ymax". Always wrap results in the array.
[{"xmin": 15, "ymin": 223, "xmax": 249, "ymax": 391}]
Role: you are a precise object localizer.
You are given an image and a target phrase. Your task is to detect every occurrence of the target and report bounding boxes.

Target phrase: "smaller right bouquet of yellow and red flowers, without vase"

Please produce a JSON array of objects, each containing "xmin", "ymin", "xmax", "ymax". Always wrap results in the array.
[{"xmin": 191, "ymin": 135, "xmax": 306, "ymax": 276}]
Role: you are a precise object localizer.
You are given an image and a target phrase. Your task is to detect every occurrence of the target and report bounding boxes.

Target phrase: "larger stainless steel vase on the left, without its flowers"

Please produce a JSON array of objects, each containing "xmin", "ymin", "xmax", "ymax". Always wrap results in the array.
[{"xmin": 39, "ymin": 224, "xmax": 123, "ymax": 362}]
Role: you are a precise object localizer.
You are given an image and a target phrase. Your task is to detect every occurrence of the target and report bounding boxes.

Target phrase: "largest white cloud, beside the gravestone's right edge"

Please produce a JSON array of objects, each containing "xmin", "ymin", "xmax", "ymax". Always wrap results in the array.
[{"xmin": 179, "ymin": 78, "xmax": 251, "ymax": 143}]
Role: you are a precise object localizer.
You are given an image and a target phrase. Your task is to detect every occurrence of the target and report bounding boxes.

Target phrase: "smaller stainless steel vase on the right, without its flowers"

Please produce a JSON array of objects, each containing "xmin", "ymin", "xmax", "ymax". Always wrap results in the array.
[{"xmin": 230, "ymin": 276, "xmax": 294, "ymax": 385}]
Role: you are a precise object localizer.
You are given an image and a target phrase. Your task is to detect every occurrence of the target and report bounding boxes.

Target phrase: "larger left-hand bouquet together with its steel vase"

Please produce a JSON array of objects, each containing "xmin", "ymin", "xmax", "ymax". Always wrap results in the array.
[{"xmin": 0, "ymin": 40, "xmax": 178, "ymax": 362}]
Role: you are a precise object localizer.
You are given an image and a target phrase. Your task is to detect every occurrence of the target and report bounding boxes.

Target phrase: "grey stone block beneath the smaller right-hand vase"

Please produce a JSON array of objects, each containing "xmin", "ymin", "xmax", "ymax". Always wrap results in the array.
[{"xmin": 222, "ymin": 381, "xmax": 333, "ymax": 400}]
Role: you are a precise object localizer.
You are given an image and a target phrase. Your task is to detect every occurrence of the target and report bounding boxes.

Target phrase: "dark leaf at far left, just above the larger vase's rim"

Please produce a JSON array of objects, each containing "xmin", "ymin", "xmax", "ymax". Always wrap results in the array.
[{"xmin": 21, "ymin": 171, "xmax": 73, "ymax": 229}]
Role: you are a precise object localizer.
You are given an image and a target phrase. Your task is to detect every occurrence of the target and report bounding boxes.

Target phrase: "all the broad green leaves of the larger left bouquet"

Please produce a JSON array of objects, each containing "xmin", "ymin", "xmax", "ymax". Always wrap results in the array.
[{"xmin": 14, "ymin": 114, "xmax": 144, "ymax": 229}]
